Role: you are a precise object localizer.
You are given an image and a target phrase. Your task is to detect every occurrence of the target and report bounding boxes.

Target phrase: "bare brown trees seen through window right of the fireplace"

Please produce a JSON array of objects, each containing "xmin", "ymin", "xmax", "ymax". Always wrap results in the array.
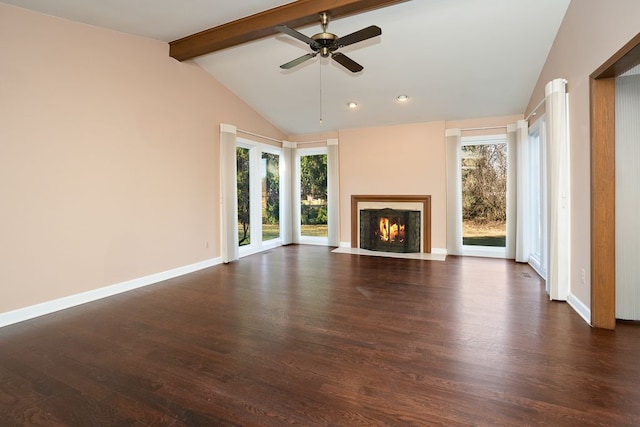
[{"xmin": 462, "ymin": 144, "xmax": 507, "ymax": 223}]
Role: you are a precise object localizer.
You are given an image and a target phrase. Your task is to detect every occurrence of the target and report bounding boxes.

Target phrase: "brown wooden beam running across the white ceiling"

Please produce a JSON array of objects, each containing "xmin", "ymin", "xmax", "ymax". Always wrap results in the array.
[{"xmin": 169, "ymin": 0, "xmax": 407, "ymax": 61}]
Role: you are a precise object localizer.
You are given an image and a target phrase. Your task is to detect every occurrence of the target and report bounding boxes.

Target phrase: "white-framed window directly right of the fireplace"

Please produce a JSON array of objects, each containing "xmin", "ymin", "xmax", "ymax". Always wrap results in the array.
[{"xmin": 460, "ymin": 135, "xmax": 508, "ymax": 256}]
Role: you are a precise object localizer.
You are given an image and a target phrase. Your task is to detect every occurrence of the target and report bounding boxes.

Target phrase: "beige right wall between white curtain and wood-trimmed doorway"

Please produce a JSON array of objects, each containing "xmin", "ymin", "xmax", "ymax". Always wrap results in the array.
[{"xmin": 527, "ymin": 0, "xmax": 640, "ymax": 307}]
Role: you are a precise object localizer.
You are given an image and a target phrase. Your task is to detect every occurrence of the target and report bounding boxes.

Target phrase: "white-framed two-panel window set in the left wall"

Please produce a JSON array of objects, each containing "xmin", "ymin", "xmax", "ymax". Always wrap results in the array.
[{"xmin": 236, "ymin": 140, "xmax": 282, "ymax": 255}]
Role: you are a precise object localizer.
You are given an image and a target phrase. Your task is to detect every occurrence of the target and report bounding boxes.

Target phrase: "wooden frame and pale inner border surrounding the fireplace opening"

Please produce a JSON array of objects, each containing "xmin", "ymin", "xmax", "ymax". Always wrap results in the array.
[{"xmin": 351, "ymin": 195, "xmax": 431, "ymax": 253}]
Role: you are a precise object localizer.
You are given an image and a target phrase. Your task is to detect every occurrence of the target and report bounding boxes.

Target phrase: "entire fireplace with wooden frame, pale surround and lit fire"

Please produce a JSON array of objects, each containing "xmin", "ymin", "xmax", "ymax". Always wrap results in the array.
[{"xmin": 351, "ymin": 194, "xmax": 431, "ymax": 254}]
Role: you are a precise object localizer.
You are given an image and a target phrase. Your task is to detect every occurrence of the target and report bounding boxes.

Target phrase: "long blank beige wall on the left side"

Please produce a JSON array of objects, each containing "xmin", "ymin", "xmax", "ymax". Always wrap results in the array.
[{"xmin": 0, "ymin": 4, "xmax": 285, "ymax": 313}]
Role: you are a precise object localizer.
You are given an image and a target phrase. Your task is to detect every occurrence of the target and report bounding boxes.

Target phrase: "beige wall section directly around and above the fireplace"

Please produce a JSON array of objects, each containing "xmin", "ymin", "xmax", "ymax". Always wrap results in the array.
[{"xmin": 339, "ymin": 122, "xmax": 447, "ymax": 248}]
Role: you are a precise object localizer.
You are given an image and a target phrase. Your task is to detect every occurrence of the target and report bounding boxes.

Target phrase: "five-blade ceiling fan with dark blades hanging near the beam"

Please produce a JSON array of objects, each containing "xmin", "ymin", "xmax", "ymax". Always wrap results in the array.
[{"xmin": 276, "ymin": 12, "xmax": 382, "ymax": 73}]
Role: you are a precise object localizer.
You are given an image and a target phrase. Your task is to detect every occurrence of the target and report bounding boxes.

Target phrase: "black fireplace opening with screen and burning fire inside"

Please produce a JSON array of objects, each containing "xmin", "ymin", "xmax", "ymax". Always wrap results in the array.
[{"xmin": 360, "ymin": 208, "xmax": 420, "ymax": 253}]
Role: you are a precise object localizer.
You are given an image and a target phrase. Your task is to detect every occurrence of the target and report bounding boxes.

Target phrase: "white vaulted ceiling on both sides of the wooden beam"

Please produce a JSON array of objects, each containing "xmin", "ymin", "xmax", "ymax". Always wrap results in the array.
[{"xmin": 2, "ymin": 0, "xmax": 570, "ymax": 135}]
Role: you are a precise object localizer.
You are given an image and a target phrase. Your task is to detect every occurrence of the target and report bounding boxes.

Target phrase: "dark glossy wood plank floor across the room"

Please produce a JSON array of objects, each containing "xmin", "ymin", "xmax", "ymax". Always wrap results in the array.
[{"xmin": 0, "ymin": 246, "xmax": 640, "ymax": 427}]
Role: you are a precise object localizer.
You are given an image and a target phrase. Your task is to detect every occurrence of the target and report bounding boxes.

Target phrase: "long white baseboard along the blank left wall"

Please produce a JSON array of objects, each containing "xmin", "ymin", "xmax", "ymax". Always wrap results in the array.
[{"xmin": 0, "ymin": 258, "xmax": 222, "ymax": 328}]
